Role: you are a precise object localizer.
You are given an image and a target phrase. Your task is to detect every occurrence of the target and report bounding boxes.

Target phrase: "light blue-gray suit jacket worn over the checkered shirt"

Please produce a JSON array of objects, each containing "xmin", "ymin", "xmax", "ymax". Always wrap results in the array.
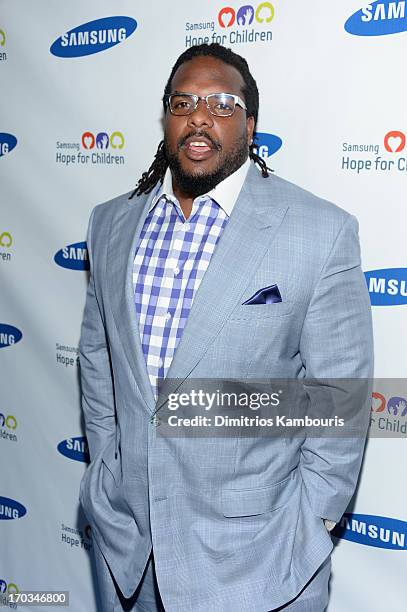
[{"xmin": 80, "ymin": 164, "xmax": 372, "ymax": 612}]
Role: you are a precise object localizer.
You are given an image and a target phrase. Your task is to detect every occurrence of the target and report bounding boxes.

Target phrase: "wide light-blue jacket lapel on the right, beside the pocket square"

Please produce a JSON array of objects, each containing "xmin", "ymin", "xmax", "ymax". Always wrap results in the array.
[{"xmin": 155, "ymin": 164, "xmax": 288, "ymax": 411}]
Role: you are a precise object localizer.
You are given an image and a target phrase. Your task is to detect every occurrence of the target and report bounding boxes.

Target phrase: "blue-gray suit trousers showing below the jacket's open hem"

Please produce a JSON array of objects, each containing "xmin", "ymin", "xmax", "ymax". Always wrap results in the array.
[{"xmin": 93, "ymin": 544, "xmax": 331, "ymax": 612}]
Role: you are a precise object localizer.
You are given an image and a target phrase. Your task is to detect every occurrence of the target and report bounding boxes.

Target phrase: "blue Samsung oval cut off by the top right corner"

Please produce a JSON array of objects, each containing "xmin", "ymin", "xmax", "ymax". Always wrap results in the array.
[{"xmin": 345, "ymin": 0, "xmax": 407, "ymax": 36}]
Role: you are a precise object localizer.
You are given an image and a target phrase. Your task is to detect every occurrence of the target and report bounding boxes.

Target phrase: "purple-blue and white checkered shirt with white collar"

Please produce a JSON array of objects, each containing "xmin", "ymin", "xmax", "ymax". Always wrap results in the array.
[{"xmin": 133, "ymin": 160, "xmax": 250, "ymax": 399}]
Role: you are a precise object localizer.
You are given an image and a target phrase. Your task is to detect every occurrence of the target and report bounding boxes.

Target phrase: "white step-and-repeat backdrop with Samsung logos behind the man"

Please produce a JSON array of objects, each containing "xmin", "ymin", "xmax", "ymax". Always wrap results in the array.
[{"xmin": 0, "ymin": 0, "xmax": 407, "ymax": 612}]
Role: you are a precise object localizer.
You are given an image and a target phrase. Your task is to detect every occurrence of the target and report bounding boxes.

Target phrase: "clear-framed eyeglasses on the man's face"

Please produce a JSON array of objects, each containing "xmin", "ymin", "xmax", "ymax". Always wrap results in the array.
[{"xmin": 163, "ymin": 93, "xmax": 247, "ymax": 117}]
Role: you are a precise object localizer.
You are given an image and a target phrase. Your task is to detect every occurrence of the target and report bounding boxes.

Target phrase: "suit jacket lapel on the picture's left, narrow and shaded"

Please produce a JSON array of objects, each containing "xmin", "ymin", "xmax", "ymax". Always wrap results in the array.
[{"xmin": 107, "ymin": 190, "xmax": 155, "ymax": 412}]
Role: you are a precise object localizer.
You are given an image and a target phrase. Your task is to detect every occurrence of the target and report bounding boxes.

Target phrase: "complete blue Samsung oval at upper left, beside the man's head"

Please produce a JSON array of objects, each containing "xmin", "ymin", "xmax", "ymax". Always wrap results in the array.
[{"xmin": 50, "ymin": 16, "xmax": 137, "ymax": 57}]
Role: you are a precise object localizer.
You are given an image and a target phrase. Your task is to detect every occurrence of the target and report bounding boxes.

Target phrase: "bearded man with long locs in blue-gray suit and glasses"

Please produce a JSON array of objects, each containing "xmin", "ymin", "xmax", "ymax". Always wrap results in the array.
[{"xmin": 80, "ymin": 45, "xmax": 372, "ymax": 612}]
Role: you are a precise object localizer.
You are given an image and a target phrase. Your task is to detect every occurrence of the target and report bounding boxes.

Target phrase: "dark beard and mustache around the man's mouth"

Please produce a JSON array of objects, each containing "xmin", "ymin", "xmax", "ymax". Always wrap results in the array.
[{"xmin": 164, "ymin": 132, "xmax": 249, "ymax": 198}]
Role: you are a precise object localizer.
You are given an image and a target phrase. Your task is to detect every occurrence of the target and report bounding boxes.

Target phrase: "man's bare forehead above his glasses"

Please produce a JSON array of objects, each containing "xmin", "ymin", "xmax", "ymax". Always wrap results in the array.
[{"xmin": 171, "ymin": 56, "xmax": 244, "ymax": 95}]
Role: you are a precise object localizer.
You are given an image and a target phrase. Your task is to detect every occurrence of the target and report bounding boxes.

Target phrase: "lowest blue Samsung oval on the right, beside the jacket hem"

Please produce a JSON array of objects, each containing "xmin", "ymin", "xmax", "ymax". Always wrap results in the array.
[{"xmin": 332, "ymin": 513, "xmax": 407, "ymax": 550}]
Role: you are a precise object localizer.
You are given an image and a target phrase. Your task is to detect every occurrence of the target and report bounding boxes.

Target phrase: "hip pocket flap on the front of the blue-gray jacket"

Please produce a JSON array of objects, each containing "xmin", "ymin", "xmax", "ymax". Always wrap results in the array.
[{"xmin": 221, "ymin": 470, "xmax": 298, "ymax": 517}]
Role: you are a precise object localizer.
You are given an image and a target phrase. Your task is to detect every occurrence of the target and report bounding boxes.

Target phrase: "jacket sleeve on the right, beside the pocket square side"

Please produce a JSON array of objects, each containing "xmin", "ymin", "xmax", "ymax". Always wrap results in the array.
[{"xmin": 300, "ymin": 216, "xmax": 373, "ymax": 522}]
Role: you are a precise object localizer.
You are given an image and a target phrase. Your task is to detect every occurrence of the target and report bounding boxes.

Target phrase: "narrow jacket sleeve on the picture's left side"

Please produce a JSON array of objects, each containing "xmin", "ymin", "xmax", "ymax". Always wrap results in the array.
[{"xmin": 79, "ymin": 210, "xmax": 116, "ymax": 461}]
